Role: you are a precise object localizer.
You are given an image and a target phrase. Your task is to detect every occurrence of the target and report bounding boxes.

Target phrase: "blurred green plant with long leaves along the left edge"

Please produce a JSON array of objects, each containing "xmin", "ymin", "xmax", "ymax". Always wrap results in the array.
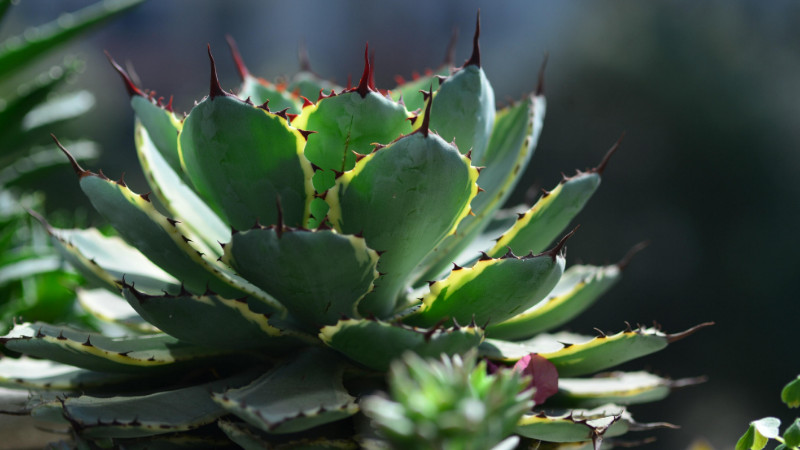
[{"xmin": 0, "ymin": 0, "xmax": 140, "ymax": 332}]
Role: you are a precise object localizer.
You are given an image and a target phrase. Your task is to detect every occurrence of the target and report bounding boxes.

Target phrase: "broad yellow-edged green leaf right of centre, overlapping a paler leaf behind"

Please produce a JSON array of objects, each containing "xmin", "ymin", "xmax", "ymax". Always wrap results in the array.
[{"xmin": 404, "ymin": 253, "xmax": 564, "ymax": 327}]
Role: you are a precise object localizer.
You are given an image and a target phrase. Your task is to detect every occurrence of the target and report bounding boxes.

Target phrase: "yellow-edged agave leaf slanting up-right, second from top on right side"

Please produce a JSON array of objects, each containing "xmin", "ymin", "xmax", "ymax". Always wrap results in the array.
[{"xmin": 488, "ymin": 169, "xmax": 600, "ymax": 257}]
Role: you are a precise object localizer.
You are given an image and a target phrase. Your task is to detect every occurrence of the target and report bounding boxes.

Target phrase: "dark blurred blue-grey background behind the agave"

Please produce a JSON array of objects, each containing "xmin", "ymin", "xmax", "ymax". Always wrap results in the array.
[{"xmin": 5, "ymin": 0, "xmax": 800, "ymax": 449}]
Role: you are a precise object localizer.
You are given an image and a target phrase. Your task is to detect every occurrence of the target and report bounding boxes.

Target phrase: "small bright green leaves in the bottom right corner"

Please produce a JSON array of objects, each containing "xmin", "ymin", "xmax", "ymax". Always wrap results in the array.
[{"xmin": 736, "ymin": 376, "xmax": 800, "ymax": 450}]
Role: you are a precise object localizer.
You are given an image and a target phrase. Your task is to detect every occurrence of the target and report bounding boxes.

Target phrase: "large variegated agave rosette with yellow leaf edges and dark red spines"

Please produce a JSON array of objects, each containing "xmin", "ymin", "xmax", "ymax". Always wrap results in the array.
[{"xmin": 0, "ymin": 15, "xmax": 705, "ymax": 448}]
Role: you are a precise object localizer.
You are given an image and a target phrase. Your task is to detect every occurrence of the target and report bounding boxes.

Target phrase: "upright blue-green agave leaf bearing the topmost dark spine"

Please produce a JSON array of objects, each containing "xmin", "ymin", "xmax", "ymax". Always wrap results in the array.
[{"xmin": 430, "ymin": 64, "xmax": 495, "ymax": 161}]
